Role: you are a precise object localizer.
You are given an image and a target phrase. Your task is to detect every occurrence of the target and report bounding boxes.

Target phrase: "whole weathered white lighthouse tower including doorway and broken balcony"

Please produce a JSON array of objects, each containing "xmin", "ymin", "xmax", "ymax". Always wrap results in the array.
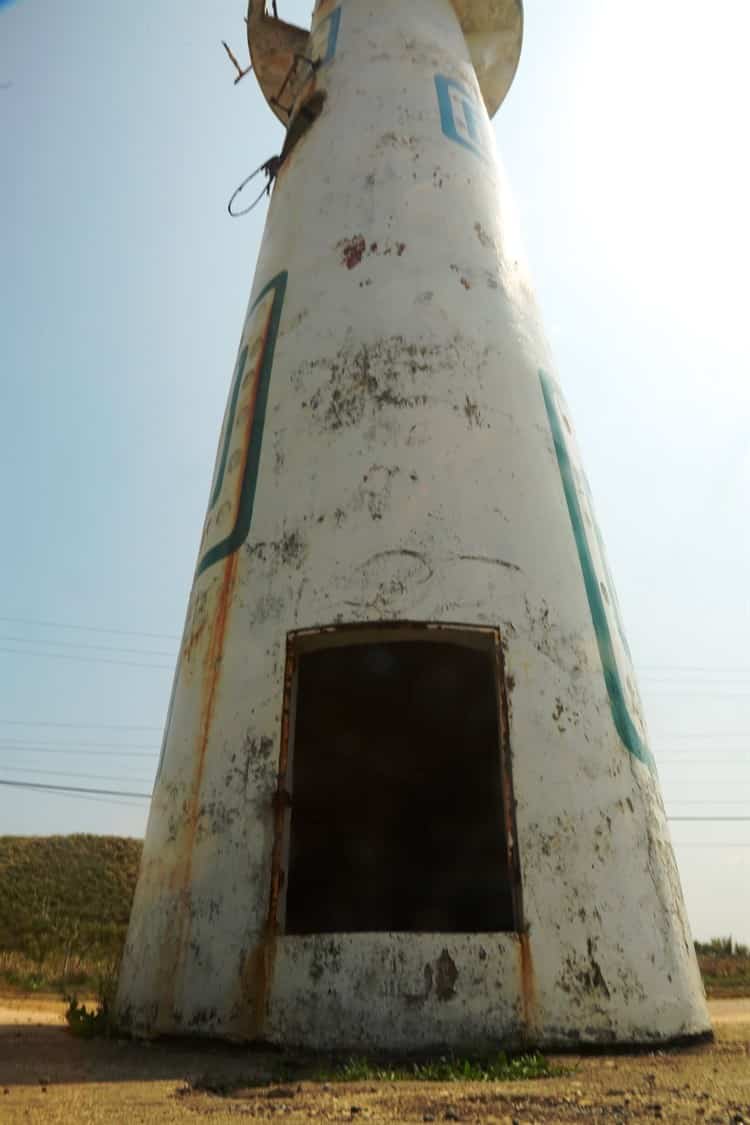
[{"xmin": 118, "ymin": 0, "xmax": 710, "ymax": 1049}]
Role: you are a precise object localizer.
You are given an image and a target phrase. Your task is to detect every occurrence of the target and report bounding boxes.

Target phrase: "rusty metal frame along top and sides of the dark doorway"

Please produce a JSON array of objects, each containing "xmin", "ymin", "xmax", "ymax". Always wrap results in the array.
[{"xmin": 266, "ymin": 621, "xmax": 525, "ymax": 938}]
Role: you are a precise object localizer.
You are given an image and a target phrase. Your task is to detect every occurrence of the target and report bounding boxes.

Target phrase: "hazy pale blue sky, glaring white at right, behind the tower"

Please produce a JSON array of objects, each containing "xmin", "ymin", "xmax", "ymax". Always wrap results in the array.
[{"xmin": 0, "ymin": 0, "xmax": 750, "ymax": 941}]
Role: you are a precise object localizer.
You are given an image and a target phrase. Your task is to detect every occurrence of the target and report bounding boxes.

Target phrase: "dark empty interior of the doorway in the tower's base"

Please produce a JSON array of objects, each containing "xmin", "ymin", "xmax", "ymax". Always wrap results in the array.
[{"xmin": 284, "ymin": 640, "xmax": 515, "ymax": 934}]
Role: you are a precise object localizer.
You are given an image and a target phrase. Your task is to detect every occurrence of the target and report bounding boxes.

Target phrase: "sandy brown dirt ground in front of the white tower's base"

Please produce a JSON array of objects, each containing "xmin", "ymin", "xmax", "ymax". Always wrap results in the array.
[{"xmin": 0, "ymin": 997, "xmax": 750, "ymax": 1125}]
